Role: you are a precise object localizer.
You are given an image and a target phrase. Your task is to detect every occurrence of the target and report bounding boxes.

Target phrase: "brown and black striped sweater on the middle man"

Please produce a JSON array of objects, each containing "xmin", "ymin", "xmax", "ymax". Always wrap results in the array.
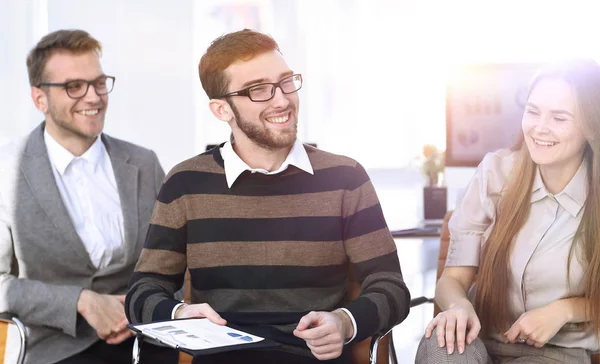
[{"xmin": 126, "ymin": 146, "xmax": 410, "ymax": 348}]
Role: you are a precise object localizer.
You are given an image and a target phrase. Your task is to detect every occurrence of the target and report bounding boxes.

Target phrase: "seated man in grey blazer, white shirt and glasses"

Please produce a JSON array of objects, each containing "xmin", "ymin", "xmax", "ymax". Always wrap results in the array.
[{"xmin": 0, "ymin": 30, "xmax": 177, "ymax": 364}]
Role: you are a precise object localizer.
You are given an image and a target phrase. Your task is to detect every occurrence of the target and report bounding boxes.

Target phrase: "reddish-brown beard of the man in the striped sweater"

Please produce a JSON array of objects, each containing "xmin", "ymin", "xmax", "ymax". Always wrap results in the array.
[{"xmin": 230, "ymin": 103, "xmax": 298, "ymax": 150}]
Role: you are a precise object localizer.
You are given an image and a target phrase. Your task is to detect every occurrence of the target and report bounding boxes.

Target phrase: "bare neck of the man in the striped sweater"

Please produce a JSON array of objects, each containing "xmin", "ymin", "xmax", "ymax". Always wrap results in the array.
[{"xmin": 232, "ymin": 139, "xmax": 292, "ymax": 172}]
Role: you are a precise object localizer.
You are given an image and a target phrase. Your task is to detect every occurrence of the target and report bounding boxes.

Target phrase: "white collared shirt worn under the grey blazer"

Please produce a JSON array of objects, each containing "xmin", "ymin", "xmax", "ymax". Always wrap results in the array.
[{"xmin": 44, "ymin": 131, "xmax": 124, "ymax": 269}]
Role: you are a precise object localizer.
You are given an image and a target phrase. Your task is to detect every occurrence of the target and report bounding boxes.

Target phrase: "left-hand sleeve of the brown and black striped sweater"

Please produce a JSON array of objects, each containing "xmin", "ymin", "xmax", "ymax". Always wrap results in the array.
[{"xmin": 125, "ymin": 173, "xmax": 187, "ymax": 323}]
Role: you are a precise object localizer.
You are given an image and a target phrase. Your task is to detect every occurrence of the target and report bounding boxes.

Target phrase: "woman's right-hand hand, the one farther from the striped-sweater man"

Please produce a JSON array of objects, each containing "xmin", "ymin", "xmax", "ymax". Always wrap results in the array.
[{"xmin": 504, "ymin": 302, "xmax": 568, "ymax": 348}]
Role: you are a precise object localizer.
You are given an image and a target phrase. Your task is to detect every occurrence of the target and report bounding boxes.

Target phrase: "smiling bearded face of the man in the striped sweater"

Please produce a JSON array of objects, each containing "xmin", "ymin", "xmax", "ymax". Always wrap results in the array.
[{"xmin": 226, "ymin": 51, "xmax": 299, "ymax": 150}]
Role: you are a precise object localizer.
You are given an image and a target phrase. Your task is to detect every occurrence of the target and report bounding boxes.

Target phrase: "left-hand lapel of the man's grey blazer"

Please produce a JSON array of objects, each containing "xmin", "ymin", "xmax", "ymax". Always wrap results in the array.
[{"xmin": 21, "ymin": 123, "xmax": 96, "ymax": 270}]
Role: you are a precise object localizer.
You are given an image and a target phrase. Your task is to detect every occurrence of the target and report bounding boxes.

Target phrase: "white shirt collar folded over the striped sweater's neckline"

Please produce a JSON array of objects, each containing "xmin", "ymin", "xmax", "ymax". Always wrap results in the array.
[{"xmin": 221, "ymin": 139, "xmax": 314, "ymax": 188}]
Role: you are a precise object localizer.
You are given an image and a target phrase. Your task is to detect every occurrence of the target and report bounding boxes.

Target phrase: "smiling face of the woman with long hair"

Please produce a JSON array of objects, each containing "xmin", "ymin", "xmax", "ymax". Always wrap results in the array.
[{"xmin": 521, "ymin": 78, "xmax": 587, "ymax": 176}]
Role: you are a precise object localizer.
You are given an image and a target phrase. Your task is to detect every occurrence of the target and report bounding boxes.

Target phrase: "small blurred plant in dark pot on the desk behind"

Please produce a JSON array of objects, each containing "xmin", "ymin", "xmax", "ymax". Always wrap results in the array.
[{"xmin": 422, "ymin": 145, "xmax": 448, "ymax": 220}]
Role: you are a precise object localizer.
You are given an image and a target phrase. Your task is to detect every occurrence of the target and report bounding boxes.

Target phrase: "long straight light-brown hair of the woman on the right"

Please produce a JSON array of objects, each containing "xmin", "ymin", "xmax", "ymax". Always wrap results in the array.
[{"xmin": 474, "ymin": 60, "xmax": 600, "ymax": 336}]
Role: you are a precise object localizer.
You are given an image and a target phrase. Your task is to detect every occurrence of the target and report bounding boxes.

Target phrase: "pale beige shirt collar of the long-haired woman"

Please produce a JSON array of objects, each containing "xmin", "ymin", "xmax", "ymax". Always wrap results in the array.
[{"xmin": 531, "ymin": 160, "xmax": 588, "ymax": 217}]
